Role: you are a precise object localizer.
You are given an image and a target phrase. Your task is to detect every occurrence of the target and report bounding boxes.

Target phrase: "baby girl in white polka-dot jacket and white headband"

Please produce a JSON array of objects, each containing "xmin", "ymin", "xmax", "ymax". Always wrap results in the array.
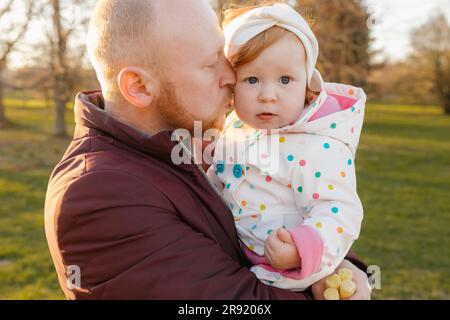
[{"xmin": 208, "ymin": 3, "xmax": 366, "ymax": 290}]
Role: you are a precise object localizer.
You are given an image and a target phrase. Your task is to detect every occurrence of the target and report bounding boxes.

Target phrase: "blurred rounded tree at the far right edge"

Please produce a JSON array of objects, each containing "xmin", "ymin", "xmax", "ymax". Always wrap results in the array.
[{"xmin": 411, "ymin": 13, "xmax": 450, "ymax": 115}]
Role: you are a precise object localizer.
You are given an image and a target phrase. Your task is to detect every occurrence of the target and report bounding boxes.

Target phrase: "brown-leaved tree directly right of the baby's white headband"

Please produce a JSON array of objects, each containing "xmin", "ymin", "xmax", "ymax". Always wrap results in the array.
[{"xmin": 296, "ymin": 0, "xmax": 371, "ymax": 86}]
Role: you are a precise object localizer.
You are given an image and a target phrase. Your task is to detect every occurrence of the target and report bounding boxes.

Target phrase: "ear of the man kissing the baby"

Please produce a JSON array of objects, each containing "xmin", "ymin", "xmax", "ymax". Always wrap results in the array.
[{"xmin": 117, "ymin": 67, "xmax": 156, "ymax": 108}]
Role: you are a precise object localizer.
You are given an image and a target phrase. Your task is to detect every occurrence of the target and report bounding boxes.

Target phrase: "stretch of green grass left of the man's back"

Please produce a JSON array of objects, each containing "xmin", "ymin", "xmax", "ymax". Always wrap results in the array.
[{"xmin": 0, "ymin": 101, "xmax": 73, "ymax": 299}]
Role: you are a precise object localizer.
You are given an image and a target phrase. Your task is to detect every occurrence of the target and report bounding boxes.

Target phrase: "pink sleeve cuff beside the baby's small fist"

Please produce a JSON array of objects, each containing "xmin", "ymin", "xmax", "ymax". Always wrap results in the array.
[{"xmin": 282, "ymin": 225, "xmax": 323, "ymax": 280}]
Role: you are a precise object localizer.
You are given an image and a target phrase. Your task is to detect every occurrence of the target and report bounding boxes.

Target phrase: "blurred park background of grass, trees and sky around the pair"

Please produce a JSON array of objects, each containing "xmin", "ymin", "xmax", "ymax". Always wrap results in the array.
[{"xmin": 0, "ymin": 0, "xmax": 450, "ymax": 299}]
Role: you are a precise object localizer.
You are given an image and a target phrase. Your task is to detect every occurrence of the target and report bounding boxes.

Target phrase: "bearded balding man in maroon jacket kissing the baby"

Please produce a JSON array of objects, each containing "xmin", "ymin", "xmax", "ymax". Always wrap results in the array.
[{"xmin": 45, "ymin": 0, "xmax": 370, "ymax": 299}]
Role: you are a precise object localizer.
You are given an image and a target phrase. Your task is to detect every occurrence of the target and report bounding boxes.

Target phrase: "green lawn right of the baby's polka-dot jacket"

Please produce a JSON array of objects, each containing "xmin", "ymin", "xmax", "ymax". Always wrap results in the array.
[{"xmin": 354, "ymin": 105, "xmax": 450, "ymax": 299}]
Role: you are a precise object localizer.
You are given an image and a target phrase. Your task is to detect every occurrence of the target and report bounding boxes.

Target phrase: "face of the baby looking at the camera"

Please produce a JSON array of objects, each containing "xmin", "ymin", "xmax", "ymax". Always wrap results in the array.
[{"xmin": 234, "ymin": 33, "xmax": 307, "ymax": 129}]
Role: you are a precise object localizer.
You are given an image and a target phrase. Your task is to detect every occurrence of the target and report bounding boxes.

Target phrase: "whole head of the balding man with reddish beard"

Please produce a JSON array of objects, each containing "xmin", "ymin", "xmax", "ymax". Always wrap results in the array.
[{"xmin": 87, "ymin": 0, "xmax": 235, "ymax": 132}]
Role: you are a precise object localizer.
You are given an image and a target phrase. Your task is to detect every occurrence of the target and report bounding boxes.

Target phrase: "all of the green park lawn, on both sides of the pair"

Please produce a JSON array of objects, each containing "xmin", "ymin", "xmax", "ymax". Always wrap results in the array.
[{"xmin": 0, "ymin": 100, "xmax": 450, "ymax": 299}]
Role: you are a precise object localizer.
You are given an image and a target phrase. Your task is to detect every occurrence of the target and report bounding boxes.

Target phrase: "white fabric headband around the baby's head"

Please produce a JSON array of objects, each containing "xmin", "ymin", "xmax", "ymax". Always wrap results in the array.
[{"xmin": 224, "ymin": 3, "xmax": 323, "ymax": 91}]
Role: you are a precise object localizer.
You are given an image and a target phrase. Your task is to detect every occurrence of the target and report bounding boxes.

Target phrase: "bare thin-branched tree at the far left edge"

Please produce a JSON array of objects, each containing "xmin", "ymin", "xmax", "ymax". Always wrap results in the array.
[{"xmin": 0, "ymin": 0, "xmax": 34, "ymax": 128}]
